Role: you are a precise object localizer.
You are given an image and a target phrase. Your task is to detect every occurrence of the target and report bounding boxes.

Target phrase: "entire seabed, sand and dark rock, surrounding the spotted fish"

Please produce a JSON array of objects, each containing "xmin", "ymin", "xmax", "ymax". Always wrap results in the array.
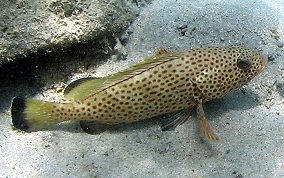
[{"xmin": 0, "ymin": 0, "xmax": 284, "ymax": 178}]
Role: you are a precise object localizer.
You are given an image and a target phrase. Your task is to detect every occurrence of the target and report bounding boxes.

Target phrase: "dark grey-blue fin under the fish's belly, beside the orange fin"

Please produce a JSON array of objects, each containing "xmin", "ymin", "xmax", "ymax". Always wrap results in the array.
[{"xmin": 161, "ymin": 108, "xmax": 192, "ymax": 131}]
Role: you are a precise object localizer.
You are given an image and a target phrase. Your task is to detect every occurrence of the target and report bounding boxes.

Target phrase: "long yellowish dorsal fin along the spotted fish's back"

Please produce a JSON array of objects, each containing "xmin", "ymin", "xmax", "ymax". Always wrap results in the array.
[{"xmin": 64, "ymin": 52, "xmax": 183, "ymax": 102}]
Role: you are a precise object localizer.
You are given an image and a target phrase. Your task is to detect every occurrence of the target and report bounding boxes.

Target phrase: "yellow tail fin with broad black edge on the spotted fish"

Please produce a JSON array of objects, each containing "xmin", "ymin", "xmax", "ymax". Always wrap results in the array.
[{"xmin": 11, "ymin": 98, "xmax": 69, "ymax": 132}]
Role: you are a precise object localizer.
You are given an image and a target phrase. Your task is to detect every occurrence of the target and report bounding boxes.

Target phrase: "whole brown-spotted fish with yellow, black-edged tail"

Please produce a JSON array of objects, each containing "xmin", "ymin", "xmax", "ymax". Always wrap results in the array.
[{"xmin": 11, "ymin": 45, "xmax": 267, "ymax": 140}]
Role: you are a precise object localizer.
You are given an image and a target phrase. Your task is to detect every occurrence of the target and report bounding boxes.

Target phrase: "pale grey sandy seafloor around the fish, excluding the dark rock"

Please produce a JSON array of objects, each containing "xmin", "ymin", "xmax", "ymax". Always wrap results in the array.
[{"xmin": 0, "ymin": 0, "xmax": 284, "ymax": 178}]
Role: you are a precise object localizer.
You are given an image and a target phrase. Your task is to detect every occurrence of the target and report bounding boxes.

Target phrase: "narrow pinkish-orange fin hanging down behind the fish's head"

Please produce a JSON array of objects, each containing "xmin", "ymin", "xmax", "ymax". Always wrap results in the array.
[{"xmin": 196, "ymin": 99, "xmax": 219, "ymax": 140}]
